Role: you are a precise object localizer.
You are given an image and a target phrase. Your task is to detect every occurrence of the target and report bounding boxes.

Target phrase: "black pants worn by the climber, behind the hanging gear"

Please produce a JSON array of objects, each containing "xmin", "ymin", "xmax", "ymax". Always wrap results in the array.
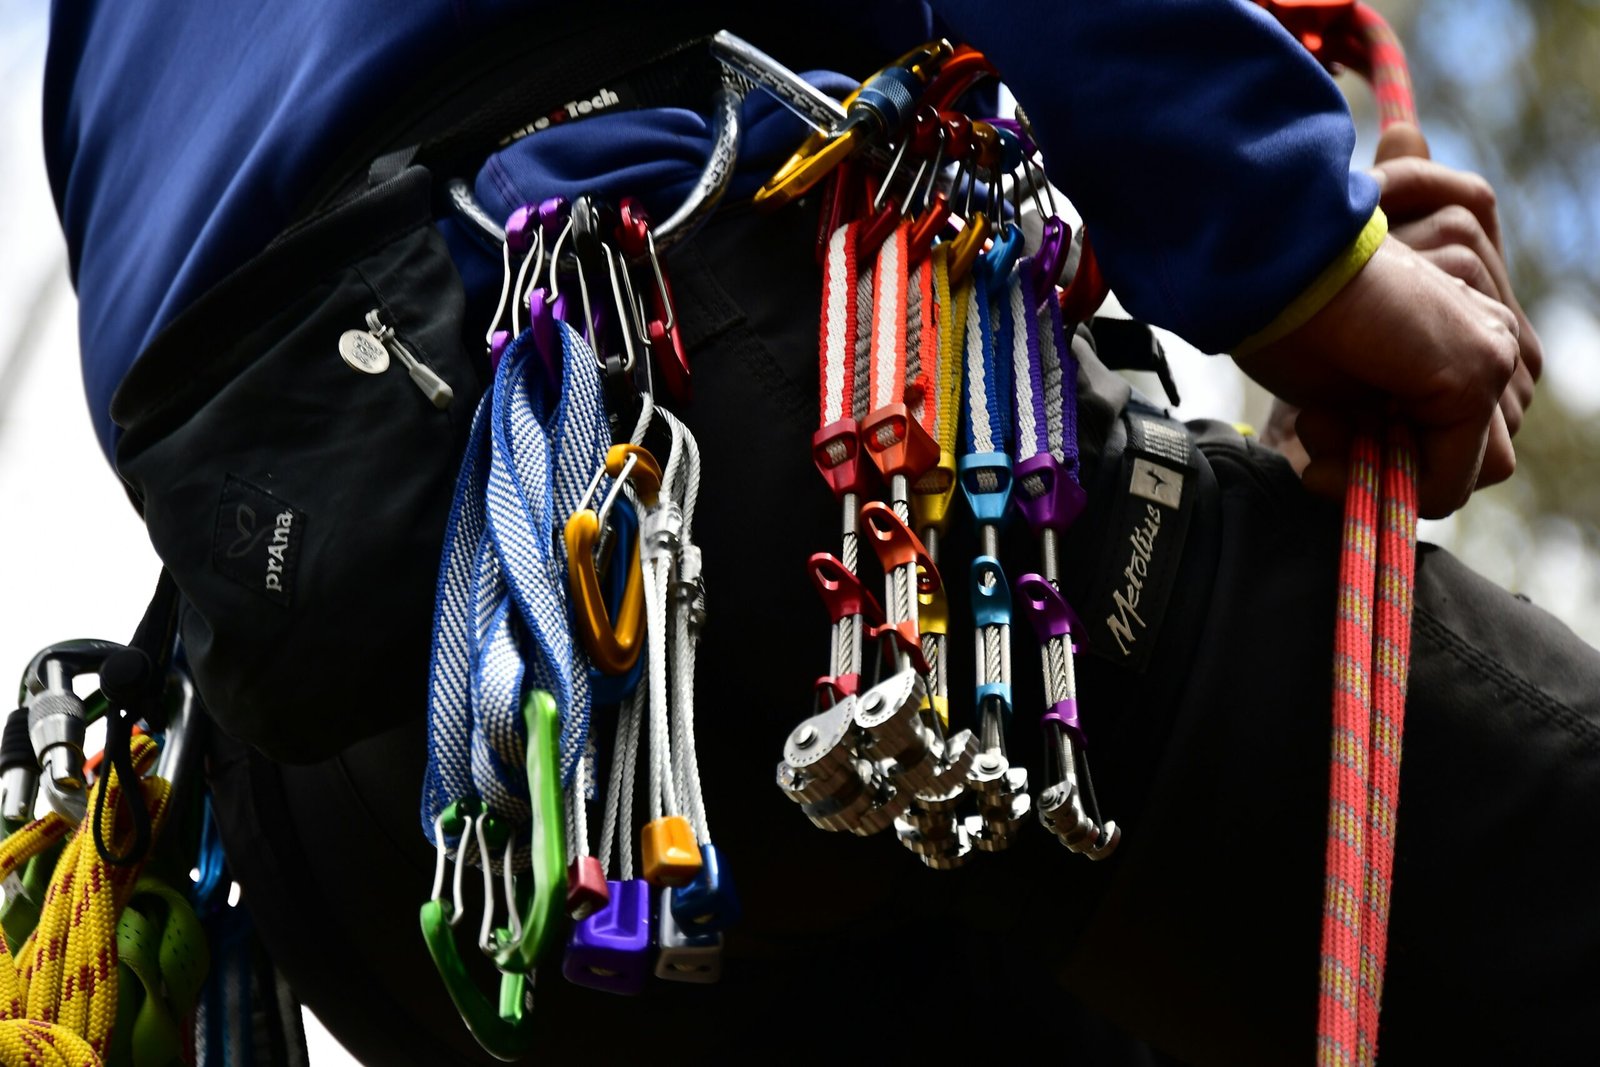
[{"xmin": 211, "ymin": 202, "xmax": 1600, "ymax": 1064}]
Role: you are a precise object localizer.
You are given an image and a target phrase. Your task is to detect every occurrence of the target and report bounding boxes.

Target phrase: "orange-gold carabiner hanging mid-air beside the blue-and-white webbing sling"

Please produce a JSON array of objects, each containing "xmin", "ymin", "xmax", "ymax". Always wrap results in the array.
[{"xmin": 563, "ymin": 445, "xmax": 661, "ymax": 675}]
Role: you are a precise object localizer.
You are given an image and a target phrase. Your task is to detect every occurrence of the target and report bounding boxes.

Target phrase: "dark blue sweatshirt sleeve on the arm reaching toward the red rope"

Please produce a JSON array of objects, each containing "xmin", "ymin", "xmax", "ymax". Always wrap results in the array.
[{"xmin": 933, "ymin": 0, "xmax": 1378, "ymax": 352}]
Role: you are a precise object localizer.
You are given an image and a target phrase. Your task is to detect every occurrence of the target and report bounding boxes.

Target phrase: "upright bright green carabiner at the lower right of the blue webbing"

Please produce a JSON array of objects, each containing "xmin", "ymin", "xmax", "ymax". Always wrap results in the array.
[{"xmin": 494, "ymin": 689, "xmax": 566, "ymax": 973}]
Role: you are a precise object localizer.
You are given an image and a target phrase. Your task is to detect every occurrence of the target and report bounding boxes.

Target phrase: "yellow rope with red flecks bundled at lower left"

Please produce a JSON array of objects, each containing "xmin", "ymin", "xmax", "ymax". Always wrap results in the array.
[{"xmin": 0, "ymin": 737, "xmax": 173, "ymax": 1067}]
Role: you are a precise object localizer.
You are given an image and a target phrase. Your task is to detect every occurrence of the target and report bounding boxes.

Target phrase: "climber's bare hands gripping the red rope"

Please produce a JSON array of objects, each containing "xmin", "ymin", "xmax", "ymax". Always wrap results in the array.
[{"xmin": 1238, "ymin": 128, "xmax": 1542, "ymax": 517}]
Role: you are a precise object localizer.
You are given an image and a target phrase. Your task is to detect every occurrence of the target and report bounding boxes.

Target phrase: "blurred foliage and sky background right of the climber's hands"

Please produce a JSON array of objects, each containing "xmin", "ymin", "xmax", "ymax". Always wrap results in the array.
[{"xmin": 1347, "ymin": 0, "xmax": 1600, "ymax": 643}]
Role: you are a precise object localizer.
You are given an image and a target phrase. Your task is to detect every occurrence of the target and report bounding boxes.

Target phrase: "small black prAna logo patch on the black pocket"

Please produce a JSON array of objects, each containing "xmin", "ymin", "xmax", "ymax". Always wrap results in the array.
[{"xmin": 211, "ymin": 475, "xmax": 306, "ymax": 608}]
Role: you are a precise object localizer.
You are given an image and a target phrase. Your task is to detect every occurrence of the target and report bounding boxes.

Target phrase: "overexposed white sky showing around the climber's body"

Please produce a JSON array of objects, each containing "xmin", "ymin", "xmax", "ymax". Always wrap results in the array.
[{"xmin": 0, "ymin": 0, "xmax": 1600, "ymax": 1067}]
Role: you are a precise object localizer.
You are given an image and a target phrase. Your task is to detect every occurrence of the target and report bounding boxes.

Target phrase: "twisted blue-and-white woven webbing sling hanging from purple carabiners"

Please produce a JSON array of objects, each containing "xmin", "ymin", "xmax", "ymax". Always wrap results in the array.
[{"xmin": 421, "ymin": 316, "xmax": 608, "ymax": 844}]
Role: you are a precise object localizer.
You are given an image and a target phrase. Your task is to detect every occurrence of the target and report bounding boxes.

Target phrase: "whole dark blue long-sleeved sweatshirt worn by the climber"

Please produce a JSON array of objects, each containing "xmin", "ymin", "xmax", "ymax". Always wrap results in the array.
[{"xmin": 45, "ymin": 0, "xmax": 1381, "ymax": 454}]
